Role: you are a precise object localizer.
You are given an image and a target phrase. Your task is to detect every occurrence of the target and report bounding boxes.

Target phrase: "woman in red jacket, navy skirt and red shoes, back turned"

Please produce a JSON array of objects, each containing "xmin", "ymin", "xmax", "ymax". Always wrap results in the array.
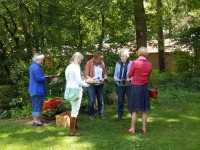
[{"xmin": 127, "ymin": 47, "xmax": 152, "ymax": 134}]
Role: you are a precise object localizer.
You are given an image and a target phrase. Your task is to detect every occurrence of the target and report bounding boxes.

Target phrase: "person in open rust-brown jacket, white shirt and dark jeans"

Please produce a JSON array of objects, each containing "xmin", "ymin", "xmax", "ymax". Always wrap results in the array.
[{"xmin": 85, "ymin": 52, "xmax": 107, "ymax": 121}]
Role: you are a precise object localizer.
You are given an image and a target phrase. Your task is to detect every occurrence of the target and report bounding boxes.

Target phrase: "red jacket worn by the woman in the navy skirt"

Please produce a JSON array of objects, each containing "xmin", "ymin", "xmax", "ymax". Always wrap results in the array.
[{"xmin": 128, "ymin": 56, "xmax": 152, "ymax": 85}]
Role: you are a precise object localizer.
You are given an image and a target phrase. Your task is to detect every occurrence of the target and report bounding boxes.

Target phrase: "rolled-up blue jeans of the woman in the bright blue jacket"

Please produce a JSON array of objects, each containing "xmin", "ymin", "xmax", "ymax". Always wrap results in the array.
[{"xmin": 31, "ymin": 95, "xmax": 44, "ymax": 117}]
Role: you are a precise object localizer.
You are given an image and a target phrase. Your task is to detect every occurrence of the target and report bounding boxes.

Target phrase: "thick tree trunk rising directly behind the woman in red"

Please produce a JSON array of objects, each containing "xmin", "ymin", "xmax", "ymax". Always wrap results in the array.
[{"xmin": 133, "ymin": 0, "xmax": 147, "ymax": 49}]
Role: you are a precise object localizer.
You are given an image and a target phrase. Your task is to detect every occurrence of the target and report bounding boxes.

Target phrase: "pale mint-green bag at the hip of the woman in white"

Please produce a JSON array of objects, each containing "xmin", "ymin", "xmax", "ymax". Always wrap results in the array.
[{"xmin": 64, "ymin": 87, "xmax": 81, "ymax": 101}]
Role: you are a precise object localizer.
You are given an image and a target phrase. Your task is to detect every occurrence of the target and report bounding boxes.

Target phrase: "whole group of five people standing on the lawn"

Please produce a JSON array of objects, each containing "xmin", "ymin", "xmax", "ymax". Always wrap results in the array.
[{"xmin": 28, "ymin": 47, "xmax": 152, "ymax": 136}]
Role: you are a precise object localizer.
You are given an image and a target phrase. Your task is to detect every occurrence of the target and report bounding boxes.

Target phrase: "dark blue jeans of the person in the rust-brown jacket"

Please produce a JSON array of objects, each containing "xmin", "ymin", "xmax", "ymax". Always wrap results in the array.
[{"xmin": 87, "ymin": 85, "xmax": 104, "ymax": 116}]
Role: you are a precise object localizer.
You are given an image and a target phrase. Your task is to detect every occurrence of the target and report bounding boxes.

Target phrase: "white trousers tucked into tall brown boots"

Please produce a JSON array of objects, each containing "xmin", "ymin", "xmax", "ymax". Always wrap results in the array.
[{"xmin": 70, "ymin": 90, "xmax": 83, "ymax": 118}]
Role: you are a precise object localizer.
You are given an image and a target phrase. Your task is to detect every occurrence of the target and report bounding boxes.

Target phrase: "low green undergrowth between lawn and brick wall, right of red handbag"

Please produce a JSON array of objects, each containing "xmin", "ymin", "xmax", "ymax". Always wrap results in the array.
[{"xmin": 154, "ymin": 71, "xmax": 200, "ymax": 104}]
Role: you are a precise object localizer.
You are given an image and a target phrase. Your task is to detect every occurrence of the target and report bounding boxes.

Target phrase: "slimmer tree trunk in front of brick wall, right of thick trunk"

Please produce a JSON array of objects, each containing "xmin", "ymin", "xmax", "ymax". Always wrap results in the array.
[{"xmin": 157, "ymin": 0, "xmax": 165, "ymax": 72}]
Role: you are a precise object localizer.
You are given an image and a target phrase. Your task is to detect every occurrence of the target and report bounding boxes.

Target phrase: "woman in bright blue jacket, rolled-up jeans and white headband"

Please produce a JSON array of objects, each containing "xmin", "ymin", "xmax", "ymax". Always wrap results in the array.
[{"xmin": 28, "ymin": 53, "xmax": 50, "ymax": 126}]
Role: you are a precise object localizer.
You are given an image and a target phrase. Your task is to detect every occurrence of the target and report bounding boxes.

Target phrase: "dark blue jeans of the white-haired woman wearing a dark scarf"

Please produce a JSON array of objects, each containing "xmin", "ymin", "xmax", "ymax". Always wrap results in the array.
[{"xmin": 117, "ymin": 86, "xmax": 131, "ymax": 119}]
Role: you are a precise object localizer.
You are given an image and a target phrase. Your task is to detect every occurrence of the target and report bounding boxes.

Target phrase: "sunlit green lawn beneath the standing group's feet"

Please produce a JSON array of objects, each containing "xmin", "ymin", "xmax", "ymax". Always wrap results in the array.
[{"xmin": 0, "ymin": 103, "xmax": 200, "ymax": 150}]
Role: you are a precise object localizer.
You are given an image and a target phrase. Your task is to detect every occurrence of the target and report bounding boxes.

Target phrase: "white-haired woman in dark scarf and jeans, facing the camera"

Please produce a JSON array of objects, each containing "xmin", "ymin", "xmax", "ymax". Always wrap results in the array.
[{"xmin": 114, "ymin": 49, "xmax": 131, "ymax": 120}]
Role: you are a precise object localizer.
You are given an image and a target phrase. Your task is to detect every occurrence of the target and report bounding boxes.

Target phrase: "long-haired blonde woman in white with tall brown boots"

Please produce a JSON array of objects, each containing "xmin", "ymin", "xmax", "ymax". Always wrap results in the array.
[{"xmin": 65, "ymin": 52, "xmax": 89, "ymax": 136}]
